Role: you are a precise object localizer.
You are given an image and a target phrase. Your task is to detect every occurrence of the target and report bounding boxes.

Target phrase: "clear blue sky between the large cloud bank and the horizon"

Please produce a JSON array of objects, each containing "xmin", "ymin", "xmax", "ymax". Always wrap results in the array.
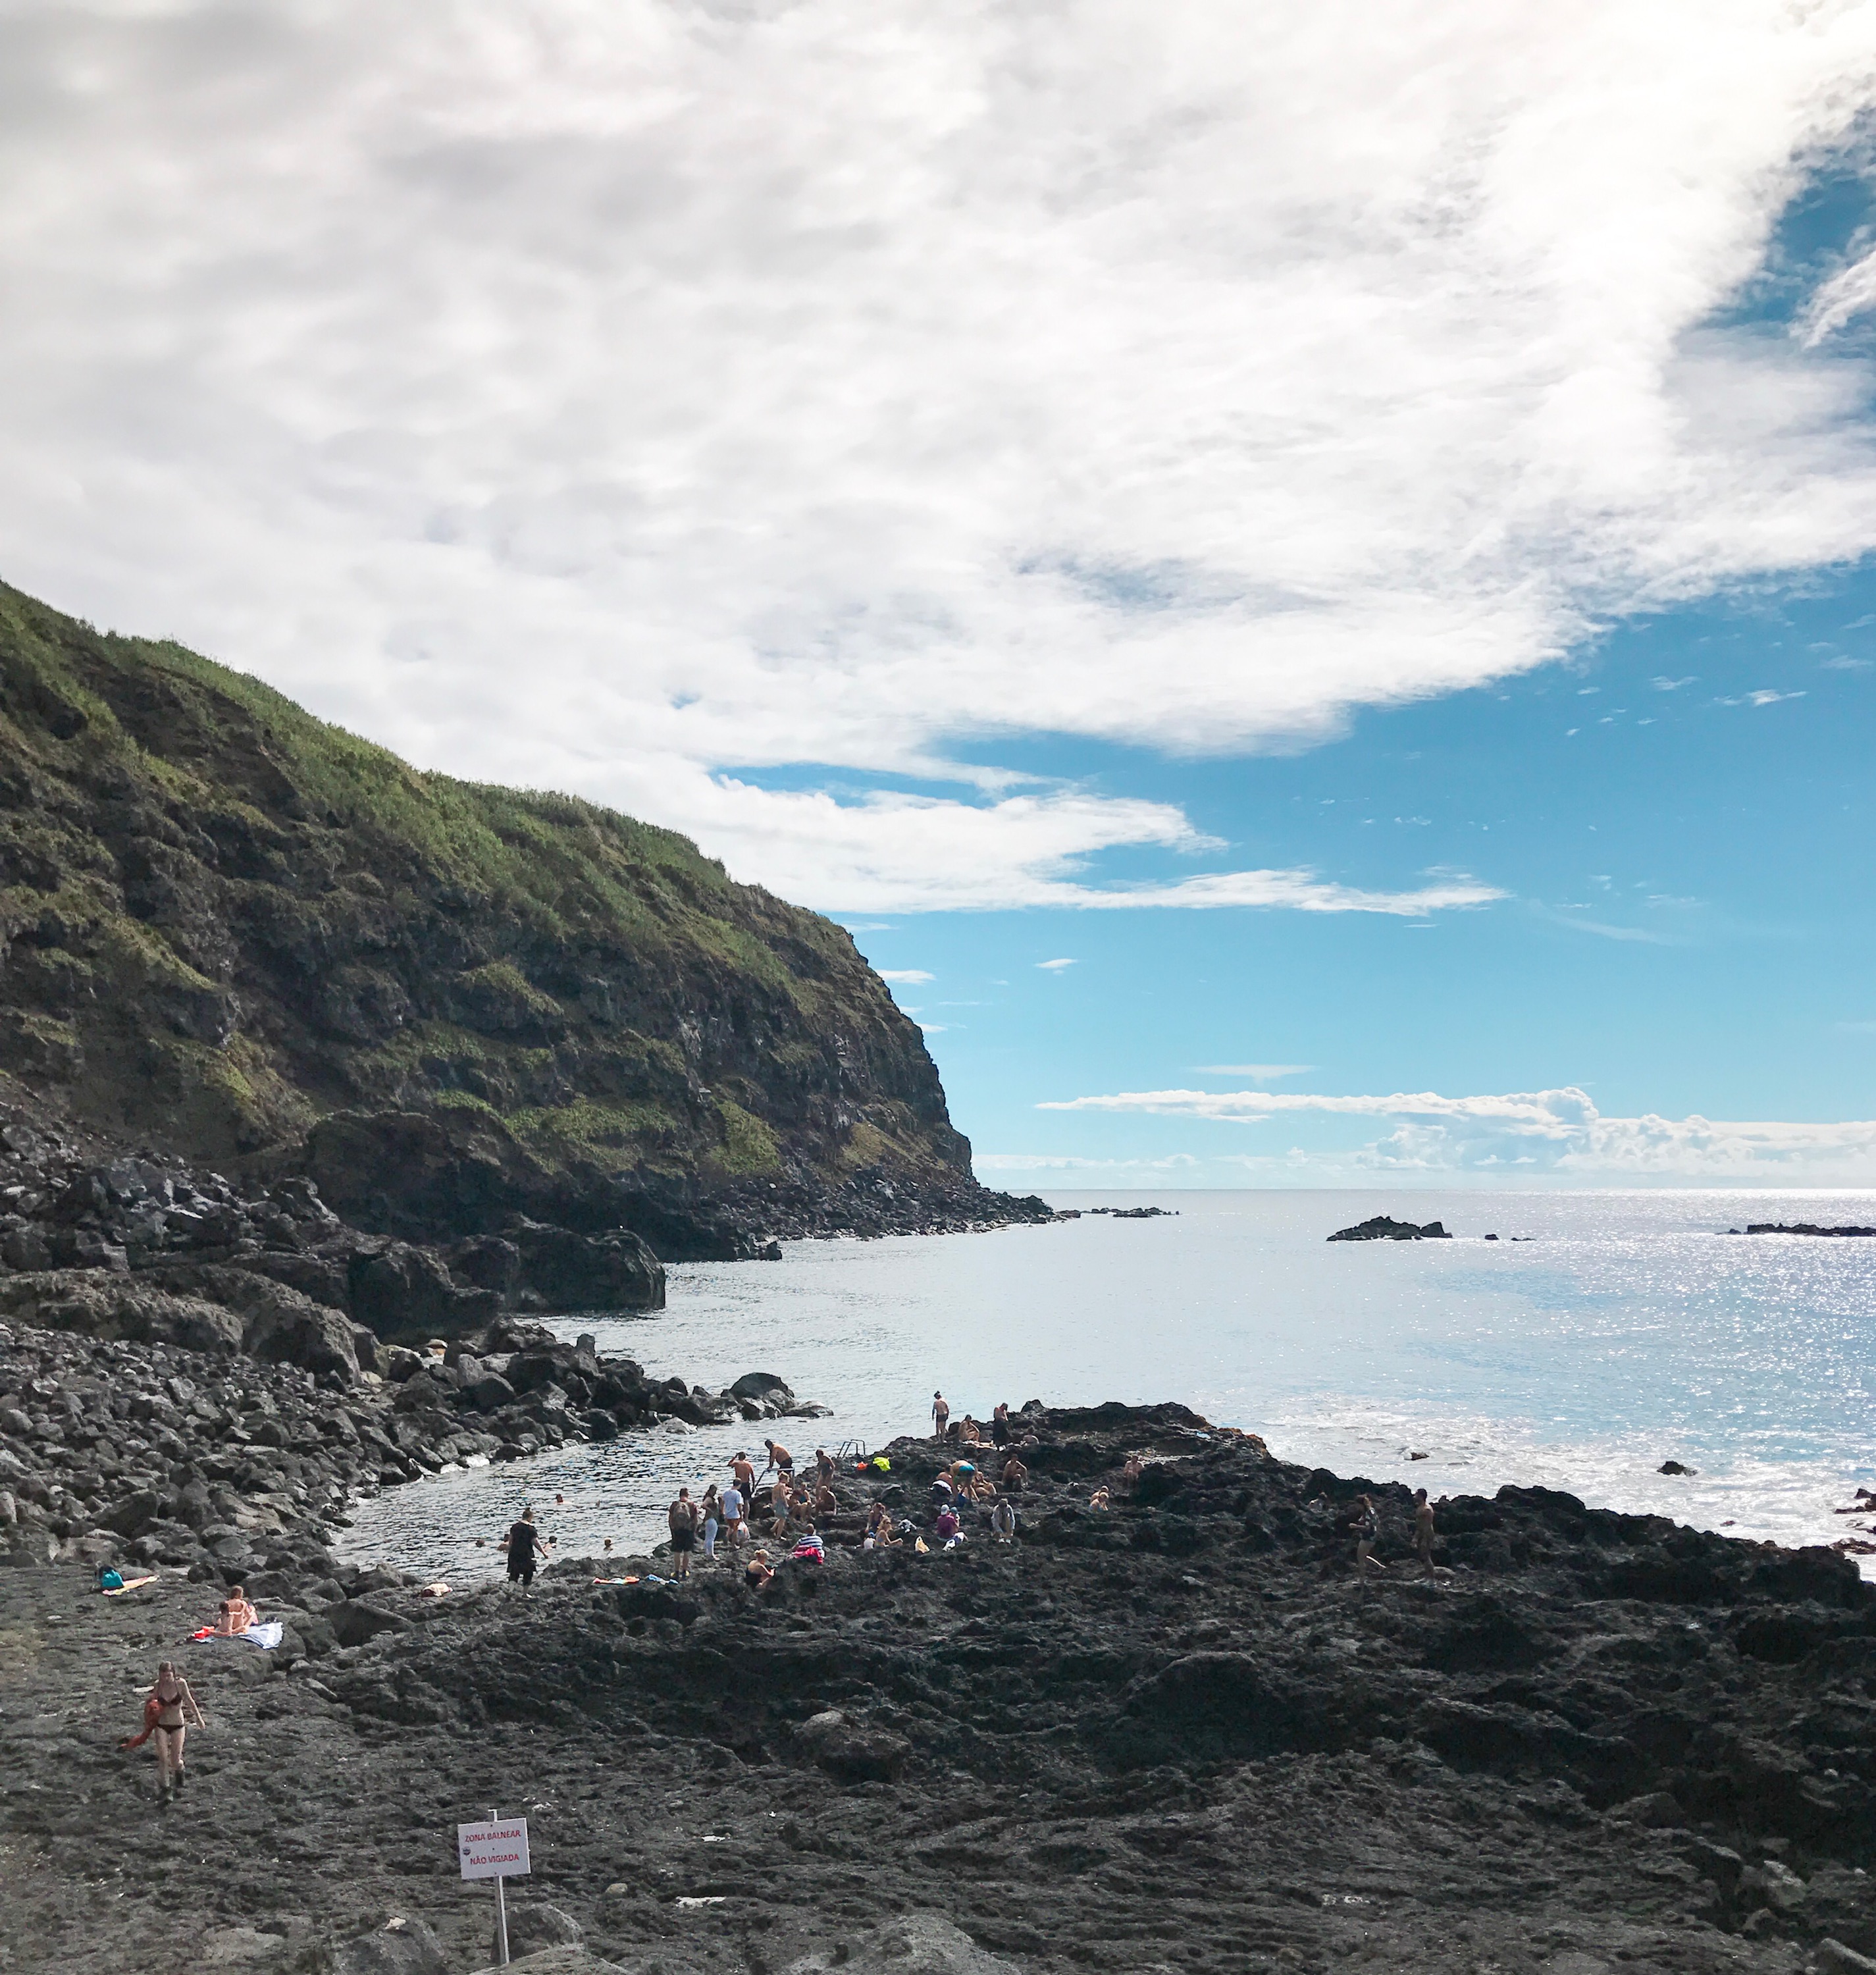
[{"xmin": 853, "ymin": 571, "xmax": 1876, "ymax": 1187}]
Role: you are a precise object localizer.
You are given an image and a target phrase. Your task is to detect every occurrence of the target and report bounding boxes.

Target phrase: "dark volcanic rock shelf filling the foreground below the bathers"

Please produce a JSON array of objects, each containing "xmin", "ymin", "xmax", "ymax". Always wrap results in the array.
[{"xmin": 0, "ymin": 1375, "xmax": 1876, "ymax": 1975}]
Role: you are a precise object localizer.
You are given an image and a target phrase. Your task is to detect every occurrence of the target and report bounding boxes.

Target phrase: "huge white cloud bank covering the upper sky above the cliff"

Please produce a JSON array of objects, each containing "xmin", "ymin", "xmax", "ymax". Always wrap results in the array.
[{"xmin": 0, "ymin": 0, "xmax": 1876, "ymax": 910}]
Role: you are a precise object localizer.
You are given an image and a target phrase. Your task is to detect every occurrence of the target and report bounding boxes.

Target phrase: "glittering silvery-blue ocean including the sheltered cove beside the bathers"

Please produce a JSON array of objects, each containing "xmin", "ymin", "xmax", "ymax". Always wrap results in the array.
[{"xmin": 342, "ymin": 1191, "xmax": 1876, "ymax": 1582}]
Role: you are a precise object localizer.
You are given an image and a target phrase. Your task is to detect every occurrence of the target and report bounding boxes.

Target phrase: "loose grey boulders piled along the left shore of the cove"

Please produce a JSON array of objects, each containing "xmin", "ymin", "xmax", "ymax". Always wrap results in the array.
[{"xmin": 0, "ymin": 1311, "xmax": 821, "ymax": 1602}]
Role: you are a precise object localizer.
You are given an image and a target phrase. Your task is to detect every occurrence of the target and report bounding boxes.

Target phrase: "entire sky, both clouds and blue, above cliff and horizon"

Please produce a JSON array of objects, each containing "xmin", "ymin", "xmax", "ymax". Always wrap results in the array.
[{"xmin": 0, "ymin": 0, "xmax": 1876, "ymax": 1189}]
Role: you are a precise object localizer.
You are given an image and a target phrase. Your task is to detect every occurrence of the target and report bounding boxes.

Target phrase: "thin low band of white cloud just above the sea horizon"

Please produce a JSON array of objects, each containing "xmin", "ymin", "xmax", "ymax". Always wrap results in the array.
[{"xmin": 1037, "ymin": 1086, "xmax": 1876, "ymax": 1185}]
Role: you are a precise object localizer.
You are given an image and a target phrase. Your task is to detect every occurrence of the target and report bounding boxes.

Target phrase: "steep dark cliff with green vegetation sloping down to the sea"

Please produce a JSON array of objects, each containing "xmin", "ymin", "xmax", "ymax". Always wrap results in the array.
[{"xmin": 0, "ymin": 587, "xmax": 1039, "ymax": 1260}]
